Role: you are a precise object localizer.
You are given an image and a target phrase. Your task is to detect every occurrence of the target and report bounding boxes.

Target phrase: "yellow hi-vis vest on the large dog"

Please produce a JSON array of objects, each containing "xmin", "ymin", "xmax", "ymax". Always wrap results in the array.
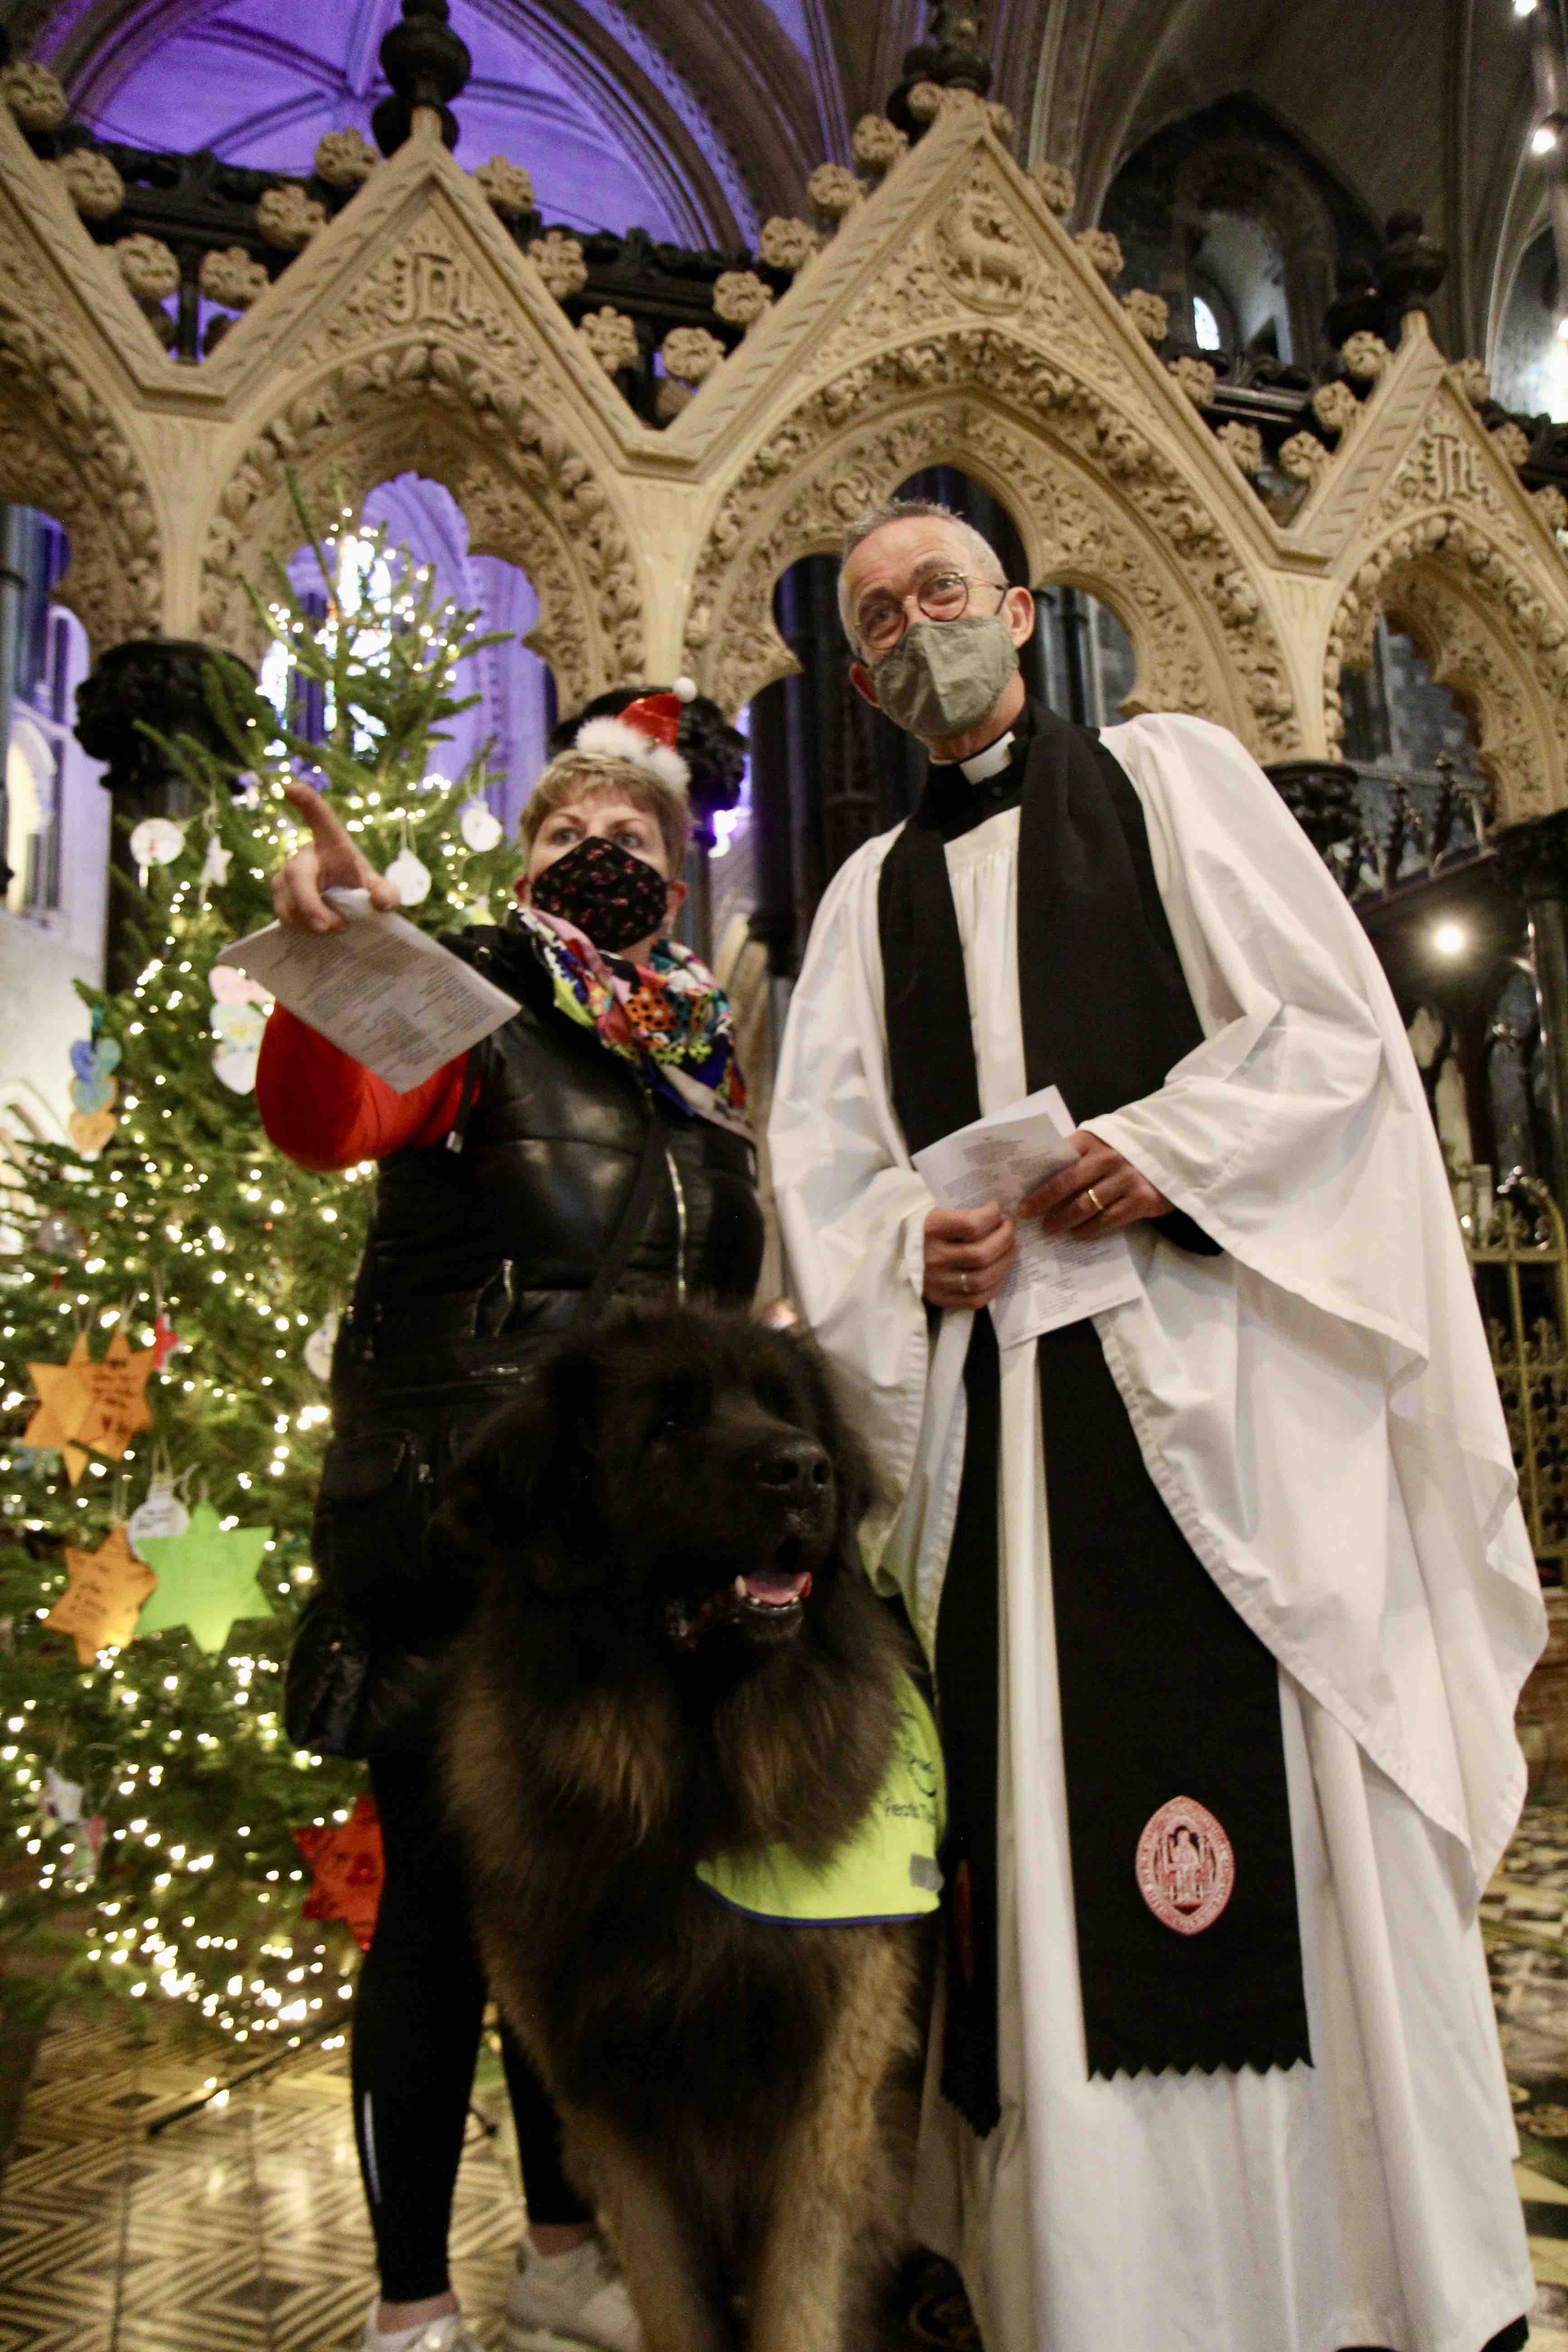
[{"xmin": 696, "ymin": 1672, "xmax": 947, "ymax": 1926}]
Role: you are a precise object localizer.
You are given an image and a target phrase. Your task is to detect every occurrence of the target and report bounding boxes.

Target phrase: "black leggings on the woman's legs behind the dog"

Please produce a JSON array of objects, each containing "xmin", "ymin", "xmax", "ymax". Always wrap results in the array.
[{"xmin": 353, "ymin": 1754, "xmax": 593, "ymax": 2303}]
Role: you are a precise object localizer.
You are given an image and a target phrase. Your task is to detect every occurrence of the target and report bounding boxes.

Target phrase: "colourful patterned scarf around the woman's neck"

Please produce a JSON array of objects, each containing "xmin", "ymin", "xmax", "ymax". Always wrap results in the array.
[{"xmin": 515, "ymin": 906, "xmax": 750, "ymax": 1136}]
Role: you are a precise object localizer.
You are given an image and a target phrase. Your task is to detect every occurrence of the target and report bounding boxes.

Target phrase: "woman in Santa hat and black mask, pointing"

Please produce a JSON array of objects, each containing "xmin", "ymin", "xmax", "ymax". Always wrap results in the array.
[{"xmin": 256, "ymin": 694, "xmax": 762, "ymax": 2352}]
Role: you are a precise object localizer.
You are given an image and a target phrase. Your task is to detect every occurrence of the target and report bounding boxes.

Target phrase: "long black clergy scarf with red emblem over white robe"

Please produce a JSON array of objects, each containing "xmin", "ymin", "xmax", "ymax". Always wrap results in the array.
[{"xmin": 879, "ymin": 708, "xmax": 1312, "ymax": 2133}]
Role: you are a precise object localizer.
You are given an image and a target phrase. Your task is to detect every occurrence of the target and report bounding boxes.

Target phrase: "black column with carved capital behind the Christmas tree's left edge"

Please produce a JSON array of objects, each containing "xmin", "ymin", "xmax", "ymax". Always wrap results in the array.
[{"xmin": 75, "ymin": 637, "xmax": 254, "ymax": 990}]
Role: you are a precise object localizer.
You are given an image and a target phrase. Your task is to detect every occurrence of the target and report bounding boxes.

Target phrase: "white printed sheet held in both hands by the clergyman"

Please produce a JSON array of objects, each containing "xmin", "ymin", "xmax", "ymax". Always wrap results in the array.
[{"xmin": 915, "ymin": 1087, "xmax": 1142, "ymax": 1348}]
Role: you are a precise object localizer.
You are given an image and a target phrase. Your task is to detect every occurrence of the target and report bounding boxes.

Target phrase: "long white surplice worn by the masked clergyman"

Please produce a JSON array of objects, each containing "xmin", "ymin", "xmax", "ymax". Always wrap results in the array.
[{"xmin": 769, "ymin": 717, "xmax": 1544, "ymax": 2352}]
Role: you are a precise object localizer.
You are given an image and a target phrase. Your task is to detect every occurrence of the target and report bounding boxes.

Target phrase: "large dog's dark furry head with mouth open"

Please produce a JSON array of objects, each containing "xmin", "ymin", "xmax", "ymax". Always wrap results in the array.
[{"xmin": 437, "ymin": 1313, "xmax": 867, "ymax": 1670}]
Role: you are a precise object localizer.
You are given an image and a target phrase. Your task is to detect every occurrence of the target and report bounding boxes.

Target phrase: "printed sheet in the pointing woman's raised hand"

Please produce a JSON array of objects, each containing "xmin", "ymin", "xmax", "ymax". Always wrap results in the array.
[{"xmin": 219, "ymin": 889, "xmax": 519, "ymax": 1094}]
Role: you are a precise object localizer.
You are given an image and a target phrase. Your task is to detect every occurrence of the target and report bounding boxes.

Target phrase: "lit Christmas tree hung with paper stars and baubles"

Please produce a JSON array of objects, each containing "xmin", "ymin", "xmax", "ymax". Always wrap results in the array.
[{"xmin": 0, "ymin": 510, "xmax": 517, "ymax": 2046}]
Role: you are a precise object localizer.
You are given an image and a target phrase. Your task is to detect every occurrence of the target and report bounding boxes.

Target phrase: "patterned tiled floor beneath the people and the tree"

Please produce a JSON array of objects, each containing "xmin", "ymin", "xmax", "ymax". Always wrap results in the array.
[{"xmin": 21, "ymin": 1806, "xmax": 1568, "ymax": 2352}]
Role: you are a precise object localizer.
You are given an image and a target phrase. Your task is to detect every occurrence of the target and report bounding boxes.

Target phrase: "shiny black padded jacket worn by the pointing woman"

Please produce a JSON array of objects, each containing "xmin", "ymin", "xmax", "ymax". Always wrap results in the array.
[{"xmin": 313, "ymin": 929, "xmax": 762, "ymax": 1750}]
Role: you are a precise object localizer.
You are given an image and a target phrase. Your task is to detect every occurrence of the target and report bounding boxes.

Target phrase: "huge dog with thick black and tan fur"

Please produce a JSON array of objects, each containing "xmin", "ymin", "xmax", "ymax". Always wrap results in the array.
[{"xmin": 437, "ymin": 1310, "xmax": 926, "ymax": 2352}]
